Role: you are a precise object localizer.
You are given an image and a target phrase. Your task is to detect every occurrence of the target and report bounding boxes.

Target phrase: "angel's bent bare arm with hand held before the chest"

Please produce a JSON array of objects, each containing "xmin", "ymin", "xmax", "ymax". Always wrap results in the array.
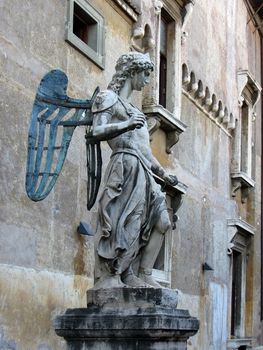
[{"xmin": 92, "ymin": 108, "xmax": 144, "ymax": 141}]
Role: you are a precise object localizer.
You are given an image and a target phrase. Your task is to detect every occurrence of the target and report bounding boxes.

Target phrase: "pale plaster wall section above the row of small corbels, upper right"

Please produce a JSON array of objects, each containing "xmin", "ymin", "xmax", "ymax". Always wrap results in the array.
[{"xmin": 182, "ymin": 0, "xmax": 260, "ymax": 113}]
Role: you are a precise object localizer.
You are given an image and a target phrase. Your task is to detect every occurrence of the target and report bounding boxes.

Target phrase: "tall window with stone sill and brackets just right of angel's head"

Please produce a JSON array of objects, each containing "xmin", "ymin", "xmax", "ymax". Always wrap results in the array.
[{"xmin": 143, "ymin": 1, "xmax": 186, "ymax": 153}]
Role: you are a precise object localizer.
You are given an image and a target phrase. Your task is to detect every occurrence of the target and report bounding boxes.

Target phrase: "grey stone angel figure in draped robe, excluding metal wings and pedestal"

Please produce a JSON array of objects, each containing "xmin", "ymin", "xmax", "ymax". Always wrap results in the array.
[{"xmin": 92, "ymin": 52, "xmax": 177, "ymax": 288}]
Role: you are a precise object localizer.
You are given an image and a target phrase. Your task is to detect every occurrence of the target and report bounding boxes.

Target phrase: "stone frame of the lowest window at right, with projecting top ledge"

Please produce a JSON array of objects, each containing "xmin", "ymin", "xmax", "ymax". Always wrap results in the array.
[{"xmin": 227, "ymin": 219, "xmax": 256, "ymax": 349}]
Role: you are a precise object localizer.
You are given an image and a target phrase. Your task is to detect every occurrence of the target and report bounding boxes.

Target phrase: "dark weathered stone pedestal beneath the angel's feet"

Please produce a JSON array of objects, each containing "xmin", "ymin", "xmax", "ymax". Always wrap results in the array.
[{"xmin": 55, "ymin": 288, "xmax": 199, "ymax": 350}]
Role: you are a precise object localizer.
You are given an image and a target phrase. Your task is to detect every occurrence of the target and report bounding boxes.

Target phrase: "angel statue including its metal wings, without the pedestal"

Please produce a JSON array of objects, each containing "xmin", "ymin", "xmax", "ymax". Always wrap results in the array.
[{"xmin": 26, "ymin": 52, "xmax": 177, "ymax": 289}]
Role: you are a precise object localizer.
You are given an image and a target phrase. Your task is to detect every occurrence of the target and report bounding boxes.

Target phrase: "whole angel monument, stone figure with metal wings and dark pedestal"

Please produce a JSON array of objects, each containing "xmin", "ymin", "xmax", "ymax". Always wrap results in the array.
[{"xmin": 26, "ymin": 52, "xmax": 199, "ymax": 350}]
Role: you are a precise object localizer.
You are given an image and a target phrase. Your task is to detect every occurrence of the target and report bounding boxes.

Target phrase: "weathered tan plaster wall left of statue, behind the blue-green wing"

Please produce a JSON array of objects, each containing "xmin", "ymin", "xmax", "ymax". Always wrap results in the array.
[{"xmin": 0, "ymin": 0, "xmax": 131, "ymax": 350}]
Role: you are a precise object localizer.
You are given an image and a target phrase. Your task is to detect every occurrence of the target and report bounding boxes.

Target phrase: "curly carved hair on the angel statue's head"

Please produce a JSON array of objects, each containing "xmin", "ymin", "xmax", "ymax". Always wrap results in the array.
[{"xmin": 108, "ymin": 52, "xmax": 154, "ymax": 95}]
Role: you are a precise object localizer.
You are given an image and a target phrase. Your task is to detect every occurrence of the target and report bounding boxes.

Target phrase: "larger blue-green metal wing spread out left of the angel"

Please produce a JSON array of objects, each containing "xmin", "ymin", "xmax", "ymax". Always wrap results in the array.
[{"xmin": 26, "ymin": 70, "xmax": 99, "ymax": 201}]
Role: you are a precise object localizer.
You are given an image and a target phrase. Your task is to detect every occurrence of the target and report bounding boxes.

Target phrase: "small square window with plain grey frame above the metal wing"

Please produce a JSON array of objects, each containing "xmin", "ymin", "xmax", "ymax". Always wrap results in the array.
[{"xmin": 66, "ymin": 0, "xmax": 105, "ymax": 68}]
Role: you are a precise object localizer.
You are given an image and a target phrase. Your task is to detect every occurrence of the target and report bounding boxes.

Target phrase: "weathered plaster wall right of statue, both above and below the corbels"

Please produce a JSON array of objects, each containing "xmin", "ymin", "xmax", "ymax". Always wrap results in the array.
[{"xmin": 165, "ymin": 0, "xmax": 261, "ymax": 350}]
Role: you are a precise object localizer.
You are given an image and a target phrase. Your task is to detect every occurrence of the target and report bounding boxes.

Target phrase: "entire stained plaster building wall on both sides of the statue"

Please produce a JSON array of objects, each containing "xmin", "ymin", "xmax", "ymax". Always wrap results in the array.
[{"xmin": 0, "ymin": 0, "xmax": 263, "ymax": 350}]
